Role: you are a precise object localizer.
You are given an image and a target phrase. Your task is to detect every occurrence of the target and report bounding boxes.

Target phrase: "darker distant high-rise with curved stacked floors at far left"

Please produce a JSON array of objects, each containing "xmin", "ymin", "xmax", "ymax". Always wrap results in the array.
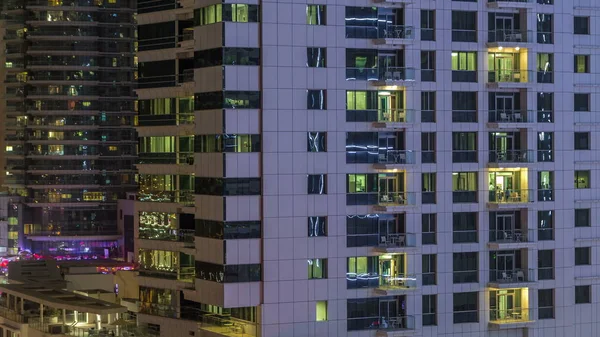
[{"xmin": 0, "ymin": 0, "xmax": 137, "ymax": 257}]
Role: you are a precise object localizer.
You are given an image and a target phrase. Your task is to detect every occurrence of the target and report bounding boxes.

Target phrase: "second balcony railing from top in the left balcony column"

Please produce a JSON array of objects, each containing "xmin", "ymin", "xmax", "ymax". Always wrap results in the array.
[{"xmin": 346, "ymin": 67, "xmax": 415, "ymax": 86}]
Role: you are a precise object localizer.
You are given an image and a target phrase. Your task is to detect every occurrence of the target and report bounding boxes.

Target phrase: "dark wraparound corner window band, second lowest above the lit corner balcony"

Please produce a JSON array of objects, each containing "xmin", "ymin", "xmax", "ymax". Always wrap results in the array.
[{"xmin": 192, "ymin": 219, "xmax": 262, "ymax": 242}]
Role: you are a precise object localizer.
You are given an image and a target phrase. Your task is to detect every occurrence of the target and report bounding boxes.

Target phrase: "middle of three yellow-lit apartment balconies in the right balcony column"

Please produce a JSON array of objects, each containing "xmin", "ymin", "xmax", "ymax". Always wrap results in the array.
[{"xmin": 488, "ymin": 168, "xmax": 533, "ymax": 203}]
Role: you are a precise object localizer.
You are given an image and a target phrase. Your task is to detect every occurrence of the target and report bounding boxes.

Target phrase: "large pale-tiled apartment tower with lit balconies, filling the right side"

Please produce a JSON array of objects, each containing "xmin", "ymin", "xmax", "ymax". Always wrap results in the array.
[{"xmin": 135, "ymin": 0, "xmax": 600, "ymax": 337}]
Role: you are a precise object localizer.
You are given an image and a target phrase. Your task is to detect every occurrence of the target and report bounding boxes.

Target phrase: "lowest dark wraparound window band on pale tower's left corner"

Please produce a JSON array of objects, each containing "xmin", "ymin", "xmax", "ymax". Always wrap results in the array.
[{"xmin": 196, "ymin": 261, "xmax": 262, "ymax": 283}]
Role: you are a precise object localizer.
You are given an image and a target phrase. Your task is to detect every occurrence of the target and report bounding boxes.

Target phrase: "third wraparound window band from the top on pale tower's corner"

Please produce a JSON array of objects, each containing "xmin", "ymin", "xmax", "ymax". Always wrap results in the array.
[{"xmin": 194, "ymin": 91, "xmax": 261, "ymax": 110}]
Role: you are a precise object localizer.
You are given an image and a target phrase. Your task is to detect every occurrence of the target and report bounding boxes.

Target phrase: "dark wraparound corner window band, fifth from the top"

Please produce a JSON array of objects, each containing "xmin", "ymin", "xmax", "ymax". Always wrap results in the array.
[{"xmin": 195, "ymin": 177, "xmax": 261, "ymax": 196}]
